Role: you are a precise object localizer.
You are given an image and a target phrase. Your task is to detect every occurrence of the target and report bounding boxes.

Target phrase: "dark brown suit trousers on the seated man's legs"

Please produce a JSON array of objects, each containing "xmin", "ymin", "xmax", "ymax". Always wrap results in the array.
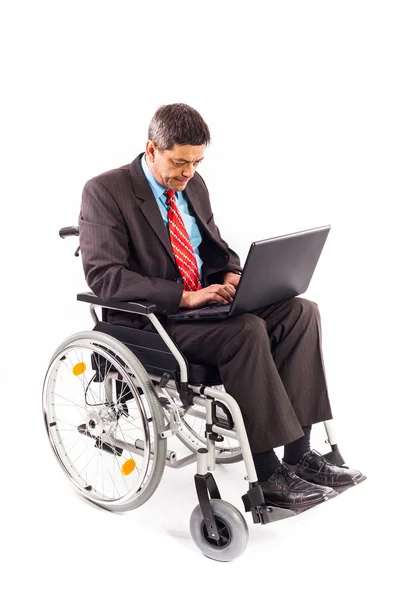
[{"xmin": 164, "ymin": 298, "xmax": 332, "ymax": 452}]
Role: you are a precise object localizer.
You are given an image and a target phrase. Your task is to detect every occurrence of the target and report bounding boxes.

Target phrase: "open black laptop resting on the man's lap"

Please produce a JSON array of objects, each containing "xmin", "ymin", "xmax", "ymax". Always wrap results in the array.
[{"xmin": 168, "ymin": 225, "xmax": 331, "ymax": 321}]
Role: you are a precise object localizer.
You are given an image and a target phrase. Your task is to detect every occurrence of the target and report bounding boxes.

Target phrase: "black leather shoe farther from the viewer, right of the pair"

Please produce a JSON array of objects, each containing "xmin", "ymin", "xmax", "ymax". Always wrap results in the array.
[{"xmin": 284, "ymin": 450, "xmax": 366, "ymax": 489}]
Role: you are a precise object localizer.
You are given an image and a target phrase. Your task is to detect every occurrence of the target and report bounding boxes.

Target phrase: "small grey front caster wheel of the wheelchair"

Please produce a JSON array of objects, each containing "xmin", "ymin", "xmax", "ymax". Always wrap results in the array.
[{"xmin": 190, "ymin": 499, "xmax": 249, "ymax": 562}]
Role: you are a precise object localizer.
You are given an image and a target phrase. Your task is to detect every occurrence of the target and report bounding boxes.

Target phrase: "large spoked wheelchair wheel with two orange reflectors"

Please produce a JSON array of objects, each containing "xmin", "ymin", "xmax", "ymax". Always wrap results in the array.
[{"xmin": 43, "ymin": 331, "xmax": 167, "ymax": 511}]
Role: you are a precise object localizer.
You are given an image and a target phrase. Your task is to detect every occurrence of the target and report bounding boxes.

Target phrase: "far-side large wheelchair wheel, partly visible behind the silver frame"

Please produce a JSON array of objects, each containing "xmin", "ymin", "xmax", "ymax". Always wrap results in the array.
[{"xmin": 176, "ymin": 386, "xmax": 243, "ymax": 464}]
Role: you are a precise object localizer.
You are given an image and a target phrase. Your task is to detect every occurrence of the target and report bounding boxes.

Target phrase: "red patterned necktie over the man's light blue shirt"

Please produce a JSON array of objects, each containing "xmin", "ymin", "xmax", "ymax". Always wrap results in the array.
[{"xmin": 164, "ymin": 190, "xmax": 202, "ymax": 292}]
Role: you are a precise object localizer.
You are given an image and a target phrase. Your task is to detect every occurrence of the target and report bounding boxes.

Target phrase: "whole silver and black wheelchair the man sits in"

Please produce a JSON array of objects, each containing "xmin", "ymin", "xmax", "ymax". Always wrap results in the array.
[{"xmin": 43, "ymin": 227, "xmax": 344, "ymax": 561}]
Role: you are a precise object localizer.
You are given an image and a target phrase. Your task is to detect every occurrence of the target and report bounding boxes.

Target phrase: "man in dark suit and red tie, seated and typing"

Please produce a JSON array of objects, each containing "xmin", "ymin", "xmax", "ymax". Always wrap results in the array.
[{"xmin": 79, "ymin": 104, "xmax": 364, "ymax": 509}]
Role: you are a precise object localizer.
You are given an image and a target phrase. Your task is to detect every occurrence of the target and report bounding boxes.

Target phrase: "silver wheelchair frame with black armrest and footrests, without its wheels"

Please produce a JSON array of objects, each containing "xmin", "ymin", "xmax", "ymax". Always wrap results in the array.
[{"xmin": 77, "ymin": 292, "xmax": 344, "ymax": 524}]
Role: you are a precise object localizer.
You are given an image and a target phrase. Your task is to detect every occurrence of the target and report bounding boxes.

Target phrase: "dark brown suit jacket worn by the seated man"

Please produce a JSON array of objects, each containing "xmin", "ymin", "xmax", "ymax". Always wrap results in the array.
[{"xmin": 79, "ymin": 153, "xmax": 240, "ymax": 328}]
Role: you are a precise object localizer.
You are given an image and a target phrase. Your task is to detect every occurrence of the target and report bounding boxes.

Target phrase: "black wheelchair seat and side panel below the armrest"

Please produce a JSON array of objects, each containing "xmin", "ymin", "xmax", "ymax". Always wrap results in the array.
[{"xmin": 93, "ymin": 321, "xmax": 222, "ymax": 386}]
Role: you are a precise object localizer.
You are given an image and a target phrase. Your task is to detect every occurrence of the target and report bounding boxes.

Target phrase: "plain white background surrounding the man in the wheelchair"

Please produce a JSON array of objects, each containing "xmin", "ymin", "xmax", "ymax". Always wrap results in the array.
[{"xmin": 0, "ymin": 0, "xmax": 400, "ymax": 600}]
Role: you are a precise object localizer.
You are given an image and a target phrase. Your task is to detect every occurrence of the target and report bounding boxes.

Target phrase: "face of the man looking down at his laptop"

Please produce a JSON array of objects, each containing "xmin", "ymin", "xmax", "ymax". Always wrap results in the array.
[{"xmin": 146, "ymin": 140, "xmax": 206, "ymax": 192}]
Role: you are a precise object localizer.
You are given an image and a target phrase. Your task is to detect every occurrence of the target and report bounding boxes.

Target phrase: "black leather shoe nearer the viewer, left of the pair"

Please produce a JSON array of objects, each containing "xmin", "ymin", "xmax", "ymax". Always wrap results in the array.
[{"xmin": 260, "ymin": 464, "xmax": 338, "ymax": 510}]
